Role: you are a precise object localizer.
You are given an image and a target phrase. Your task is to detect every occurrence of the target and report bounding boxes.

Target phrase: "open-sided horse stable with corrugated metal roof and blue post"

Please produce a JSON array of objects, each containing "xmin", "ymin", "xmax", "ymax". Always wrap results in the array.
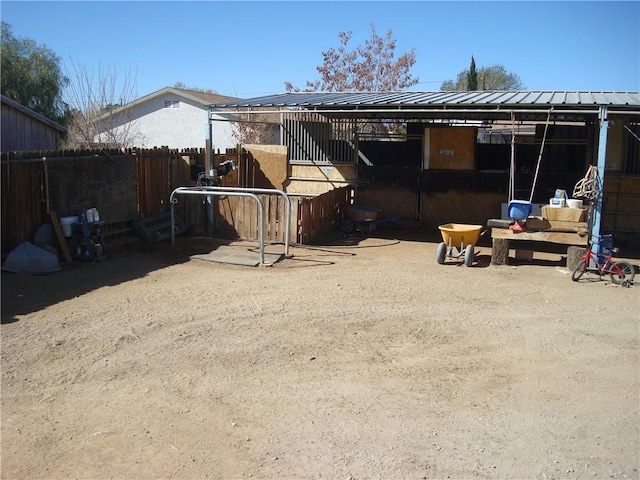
[{"xmin": 210, "ymin": 91, "xmax": 640, "ymax": 248}]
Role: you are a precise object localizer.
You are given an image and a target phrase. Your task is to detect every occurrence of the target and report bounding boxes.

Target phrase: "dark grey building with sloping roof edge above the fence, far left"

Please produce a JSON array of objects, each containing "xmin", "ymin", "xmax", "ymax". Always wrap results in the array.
[{"xmin": 0, "ymin": 95, "xmax": 67, "ymax": 152}]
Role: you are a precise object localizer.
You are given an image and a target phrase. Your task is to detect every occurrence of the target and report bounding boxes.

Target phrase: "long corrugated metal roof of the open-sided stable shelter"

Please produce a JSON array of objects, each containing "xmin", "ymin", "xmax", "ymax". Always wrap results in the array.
[{"xmin": 210, "ymin": 91, "xmax": 640, "ymax": 120}]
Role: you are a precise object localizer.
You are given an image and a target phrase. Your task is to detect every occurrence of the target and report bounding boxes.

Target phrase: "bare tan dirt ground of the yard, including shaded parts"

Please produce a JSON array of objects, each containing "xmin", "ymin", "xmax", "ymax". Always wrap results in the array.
[{"xmin": 1, "ymin": 232, "xmax": 640, "ymax": 480}]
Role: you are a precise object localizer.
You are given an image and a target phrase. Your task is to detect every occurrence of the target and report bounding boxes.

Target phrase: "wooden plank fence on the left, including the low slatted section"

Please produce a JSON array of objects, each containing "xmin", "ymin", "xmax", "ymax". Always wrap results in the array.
[{"xmin": 1, "ymin": 148, "xmax": 353, "ymax": 258}]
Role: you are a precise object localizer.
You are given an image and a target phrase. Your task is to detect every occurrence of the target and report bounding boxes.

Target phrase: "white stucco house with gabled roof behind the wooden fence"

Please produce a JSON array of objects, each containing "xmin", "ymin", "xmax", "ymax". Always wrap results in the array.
[{"xmin": 95, "ymin": 87, "xmax": 238, "ymax": 151}]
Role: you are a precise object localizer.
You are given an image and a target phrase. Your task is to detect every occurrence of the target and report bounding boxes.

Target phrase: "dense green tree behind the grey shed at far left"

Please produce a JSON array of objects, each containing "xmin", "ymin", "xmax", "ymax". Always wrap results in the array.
[{"xmin": 0, "ymin": 22, "xmax": 69, "ymax": 124}]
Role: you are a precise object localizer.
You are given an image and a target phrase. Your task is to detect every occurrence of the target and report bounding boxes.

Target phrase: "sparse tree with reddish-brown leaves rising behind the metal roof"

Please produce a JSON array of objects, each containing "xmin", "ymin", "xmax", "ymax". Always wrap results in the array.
[{"xmin": 285, "ymin": 25, "xmax": 419, "ymax": 92}]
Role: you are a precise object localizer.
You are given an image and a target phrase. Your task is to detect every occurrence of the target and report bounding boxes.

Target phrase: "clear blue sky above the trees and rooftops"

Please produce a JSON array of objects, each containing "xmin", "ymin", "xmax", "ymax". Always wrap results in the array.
[{"xmin": 0, "ymin": 0, "xmax": 640, "ymax": 98}]
